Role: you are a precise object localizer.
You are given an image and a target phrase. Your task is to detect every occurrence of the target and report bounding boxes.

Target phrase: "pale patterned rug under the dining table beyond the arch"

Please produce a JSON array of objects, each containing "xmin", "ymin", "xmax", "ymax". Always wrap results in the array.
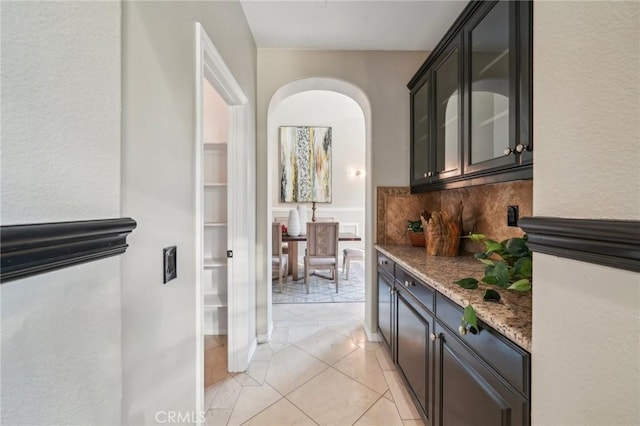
[{"xmin": 272, "ymin": 261, "xmax": 364, "ymax": 304}]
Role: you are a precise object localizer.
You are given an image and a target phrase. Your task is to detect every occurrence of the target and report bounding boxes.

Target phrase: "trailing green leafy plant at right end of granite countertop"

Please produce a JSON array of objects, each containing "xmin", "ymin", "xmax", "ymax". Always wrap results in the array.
[{"xmin": 455, "ymin": 234, "xmax": 533, "ymax": 335}]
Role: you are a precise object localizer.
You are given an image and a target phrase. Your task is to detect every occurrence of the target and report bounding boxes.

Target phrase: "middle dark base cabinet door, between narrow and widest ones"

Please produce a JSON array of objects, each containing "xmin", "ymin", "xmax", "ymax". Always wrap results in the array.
[{"xmin": 396, "ymin": 288, "xmax": 433, "ymax": 420}]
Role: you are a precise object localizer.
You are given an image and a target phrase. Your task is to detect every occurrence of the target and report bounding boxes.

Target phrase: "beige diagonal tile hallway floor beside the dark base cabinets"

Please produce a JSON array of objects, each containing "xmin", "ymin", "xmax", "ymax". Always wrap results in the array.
[{"xmin": 205, "ymin": 303, "xmax": 423, "ymax": 426}]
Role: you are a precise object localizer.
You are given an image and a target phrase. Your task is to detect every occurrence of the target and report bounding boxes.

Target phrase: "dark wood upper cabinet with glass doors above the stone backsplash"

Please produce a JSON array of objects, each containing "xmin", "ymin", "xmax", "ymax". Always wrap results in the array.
[{"xmin": 408, "ymin": 0, "xmax": 533, "ymax": 192}]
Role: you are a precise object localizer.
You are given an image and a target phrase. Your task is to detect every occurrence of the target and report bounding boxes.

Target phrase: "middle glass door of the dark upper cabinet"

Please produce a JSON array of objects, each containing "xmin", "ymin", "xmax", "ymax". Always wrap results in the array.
[{"xmin": 432, "ymin": 41, "xmax": 462, "ymax": 179}]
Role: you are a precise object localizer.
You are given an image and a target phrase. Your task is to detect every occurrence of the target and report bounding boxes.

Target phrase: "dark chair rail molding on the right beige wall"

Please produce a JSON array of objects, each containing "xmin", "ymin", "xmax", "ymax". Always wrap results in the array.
[{"xmin": 518, "ymin": 217, "xmax": 640, "ymax": 272}]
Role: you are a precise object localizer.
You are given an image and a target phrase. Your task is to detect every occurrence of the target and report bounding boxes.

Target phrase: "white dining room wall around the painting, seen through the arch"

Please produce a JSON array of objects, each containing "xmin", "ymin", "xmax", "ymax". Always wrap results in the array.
[{"xmin": 268, "ymin": 90, "xmax": 365, "ymax": 253}]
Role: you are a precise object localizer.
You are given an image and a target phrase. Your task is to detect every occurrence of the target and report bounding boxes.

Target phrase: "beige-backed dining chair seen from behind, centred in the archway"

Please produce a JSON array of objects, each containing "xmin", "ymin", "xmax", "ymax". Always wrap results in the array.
[{"xmin": 304, "ymin": 222, "xmax": 340, "ymax": 294}]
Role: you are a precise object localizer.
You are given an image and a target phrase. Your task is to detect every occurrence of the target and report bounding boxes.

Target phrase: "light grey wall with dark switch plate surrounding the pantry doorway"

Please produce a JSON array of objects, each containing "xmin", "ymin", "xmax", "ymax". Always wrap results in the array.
[{"xmin": 122, "ymin": 1, "xmax": 256, "ymax": 424}]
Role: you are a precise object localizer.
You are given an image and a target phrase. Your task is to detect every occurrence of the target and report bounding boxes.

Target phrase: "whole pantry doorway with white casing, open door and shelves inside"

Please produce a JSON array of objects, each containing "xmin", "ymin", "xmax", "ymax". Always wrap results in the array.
[{"xmin": 194, "ymin": 23, "xmax": 257, "ymax": 420}]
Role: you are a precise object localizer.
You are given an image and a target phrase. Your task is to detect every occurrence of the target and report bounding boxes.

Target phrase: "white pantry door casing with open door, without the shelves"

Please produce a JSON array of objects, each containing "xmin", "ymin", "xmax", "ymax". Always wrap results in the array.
[{"xmin": 193, "ymin": 22, "xmax": 257, "ymax": 413}]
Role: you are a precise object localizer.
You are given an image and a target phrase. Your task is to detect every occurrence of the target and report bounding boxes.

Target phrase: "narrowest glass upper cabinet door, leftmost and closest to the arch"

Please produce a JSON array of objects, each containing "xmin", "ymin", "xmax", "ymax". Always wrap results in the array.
[{"xmin": 411, "ymin": 78, "xmax": 431, "ymax": 185}]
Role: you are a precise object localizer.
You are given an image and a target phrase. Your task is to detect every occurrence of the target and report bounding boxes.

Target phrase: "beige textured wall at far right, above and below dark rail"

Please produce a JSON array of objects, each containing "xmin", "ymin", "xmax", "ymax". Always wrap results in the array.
[{"xmin": 532, "ymin": 2, "xmax": 640, "ymax": 425}]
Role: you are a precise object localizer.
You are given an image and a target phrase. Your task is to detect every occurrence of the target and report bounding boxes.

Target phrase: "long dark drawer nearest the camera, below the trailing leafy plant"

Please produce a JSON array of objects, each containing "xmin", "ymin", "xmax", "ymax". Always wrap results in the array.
[{"xmin": 436, "ymin": 293, "xmax": 531, "ymax": 397}]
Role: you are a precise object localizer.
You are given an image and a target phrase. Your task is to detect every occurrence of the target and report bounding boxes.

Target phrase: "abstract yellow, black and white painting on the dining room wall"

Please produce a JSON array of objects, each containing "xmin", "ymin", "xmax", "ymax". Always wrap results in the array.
[{"xmin": 280, "ymin": 126, "xmax": 331, "ymax": 203}]
